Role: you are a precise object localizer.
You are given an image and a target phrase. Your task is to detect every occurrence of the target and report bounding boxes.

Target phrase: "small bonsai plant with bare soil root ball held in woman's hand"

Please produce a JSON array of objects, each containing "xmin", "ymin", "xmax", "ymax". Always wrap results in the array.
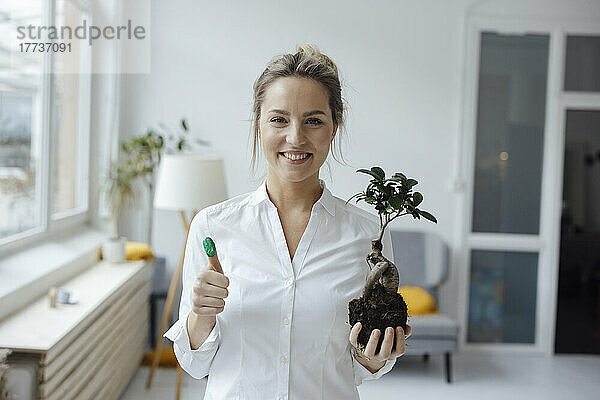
[{"xmin": 346, "ymin": 167, "xmax": 437, "ymax": 353}]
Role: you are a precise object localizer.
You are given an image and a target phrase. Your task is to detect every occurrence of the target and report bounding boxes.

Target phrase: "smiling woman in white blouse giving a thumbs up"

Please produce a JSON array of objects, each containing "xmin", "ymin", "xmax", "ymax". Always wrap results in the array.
[{"xmin": 165, "ymin": 45, "xmax": 410, "ymax": 400}]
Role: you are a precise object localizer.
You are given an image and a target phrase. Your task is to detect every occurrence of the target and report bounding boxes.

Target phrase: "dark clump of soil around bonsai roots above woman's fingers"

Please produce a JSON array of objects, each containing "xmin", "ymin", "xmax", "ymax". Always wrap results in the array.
[{"xmin": 348, "ymin": 282, "xmax": 408, "ymax": 354}]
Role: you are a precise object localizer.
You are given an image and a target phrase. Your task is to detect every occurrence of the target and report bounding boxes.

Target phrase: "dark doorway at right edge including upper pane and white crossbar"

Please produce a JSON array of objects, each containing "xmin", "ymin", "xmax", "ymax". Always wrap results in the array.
[{"xmin": 554, "ymin": 32, "xmax": 600, "ymax": 354}]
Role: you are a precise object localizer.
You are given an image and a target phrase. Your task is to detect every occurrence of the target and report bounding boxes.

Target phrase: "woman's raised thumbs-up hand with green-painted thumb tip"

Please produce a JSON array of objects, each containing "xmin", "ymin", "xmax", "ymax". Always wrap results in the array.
[{"xmin": 192, "ymin": 237, "xmax": 229, "ymax": 316}]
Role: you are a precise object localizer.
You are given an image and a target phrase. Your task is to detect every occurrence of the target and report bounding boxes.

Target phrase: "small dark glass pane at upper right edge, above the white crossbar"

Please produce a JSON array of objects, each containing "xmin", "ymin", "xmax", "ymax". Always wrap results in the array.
[{"xmin": 565, "ymin": 36, "xmax": 600, "ymax": 92}]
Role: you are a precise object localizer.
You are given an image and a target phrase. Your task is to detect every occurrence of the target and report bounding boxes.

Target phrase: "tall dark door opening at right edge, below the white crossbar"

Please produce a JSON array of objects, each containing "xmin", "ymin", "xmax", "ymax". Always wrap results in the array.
[{"xmin": 554, "ymin": 109, "xmax": 600, "ymax": 354}]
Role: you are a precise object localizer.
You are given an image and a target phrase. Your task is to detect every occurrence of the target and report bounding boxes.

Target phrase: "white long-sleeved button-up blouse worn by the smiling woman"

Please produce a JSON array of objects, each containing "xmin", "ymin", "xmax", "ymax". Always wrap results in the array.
[{"xmin": 164, "ymin": 180, "xmax": 396, "ymax": 400}]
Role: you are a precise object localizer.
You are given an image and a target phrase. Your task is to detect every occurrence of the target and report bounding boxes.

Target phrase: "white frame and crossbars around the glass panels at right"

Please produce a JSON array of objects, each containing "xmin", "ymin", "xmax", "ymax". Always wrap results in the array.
[{"xmin": 455, "ymin": 16, "xmax": 600, "ymax": 355}]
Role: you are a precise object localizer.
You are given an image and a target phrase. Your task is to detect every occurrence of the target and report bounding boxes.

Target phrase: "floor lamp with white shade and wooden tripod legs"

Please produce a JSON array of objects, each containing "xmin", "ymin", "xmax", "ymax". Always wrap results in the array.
[{"xmin": 146, "ymin": 154, "xmax": 227, "ymax": 400}]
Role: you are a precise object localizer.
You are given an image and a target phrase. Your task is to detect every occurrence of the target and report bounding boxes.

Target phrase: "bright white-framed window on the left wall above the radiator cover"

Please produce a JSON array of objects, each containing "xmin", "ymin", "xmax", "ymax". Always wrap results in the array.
[{"xmin": 0, "ymin": 0, "xmax": 91, "ymax": 247}]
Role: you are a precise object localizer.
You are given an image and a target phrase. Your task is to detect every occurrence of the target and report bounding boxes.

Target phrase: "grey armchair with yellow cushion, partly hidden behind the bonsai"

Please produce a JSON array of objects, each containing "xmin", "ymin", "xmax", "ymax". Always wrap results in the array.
[{"xmin": 390, "ymin": 229, "xmax": 458, "ymax": 383}]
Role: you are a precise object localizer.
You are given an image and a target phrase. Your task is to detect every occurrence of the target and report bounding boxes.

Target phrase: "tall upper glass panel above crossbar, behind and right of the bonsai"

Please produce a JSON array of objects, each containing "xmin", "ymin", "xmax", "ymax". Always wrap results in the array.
[{"xmin": 472, "ymin": 32, "xmax": 549, "ymax": 234}]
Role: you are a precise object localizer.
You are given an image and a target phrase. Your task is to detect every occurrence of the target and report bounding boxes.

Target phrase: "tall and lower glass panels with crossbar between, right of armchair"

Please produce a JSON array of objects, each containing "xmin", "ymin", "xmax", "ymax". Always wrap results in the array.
[{"xmin": 465, "ymin": 31, "xmax": 550, "ymax": 347}]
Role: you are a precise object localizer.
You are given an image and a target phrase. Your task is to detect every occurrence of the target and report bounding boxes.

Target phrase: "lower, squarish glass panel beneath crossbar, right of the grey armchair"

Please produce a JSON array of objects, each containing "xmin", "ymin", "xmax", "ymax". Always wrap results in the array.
[{"xmin": 467, "ymin": 250, "xmax": 538, "ymax": 343}]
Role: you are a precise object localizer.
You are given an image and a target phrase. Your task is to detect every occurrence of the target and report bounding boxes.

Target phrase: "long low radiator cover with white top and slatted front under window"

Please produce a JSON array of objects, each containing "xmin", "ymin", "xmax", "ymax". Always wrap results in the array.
[{"xmin": 0, "ymin": 261, "xmax": 152, "ymax": 400}]
